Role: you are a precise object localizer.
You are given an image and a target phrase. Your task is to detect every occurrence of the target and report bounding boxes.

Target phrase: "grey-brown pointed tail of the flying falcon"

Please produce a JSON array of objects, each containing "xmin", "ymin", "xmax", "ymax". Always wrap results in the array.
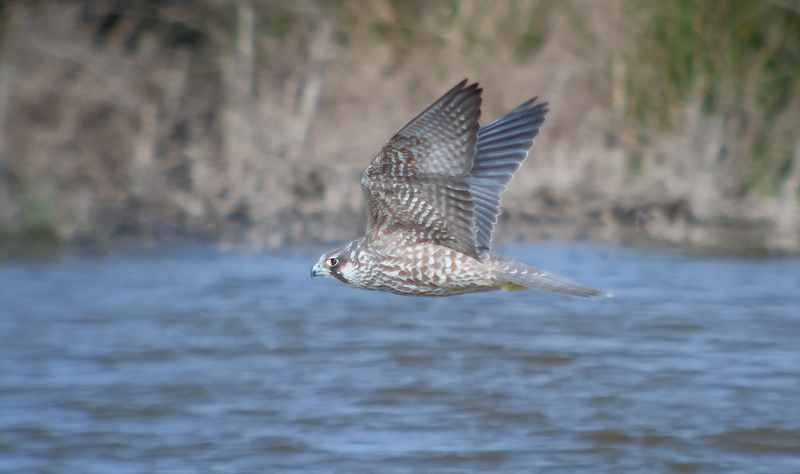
[{"xmin": 493, "ymin": 256, "xmax": 613, "ymax": 297}]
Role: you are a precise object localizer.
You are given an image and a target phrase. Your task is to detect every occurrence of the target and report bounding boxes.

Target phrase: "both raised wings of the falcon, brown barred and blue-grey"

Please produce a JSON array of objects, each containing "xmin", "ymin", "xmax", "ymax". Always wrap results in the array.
[{"xmin": 361, "ymin": 80, "xmax": 548, "ymax": 258}]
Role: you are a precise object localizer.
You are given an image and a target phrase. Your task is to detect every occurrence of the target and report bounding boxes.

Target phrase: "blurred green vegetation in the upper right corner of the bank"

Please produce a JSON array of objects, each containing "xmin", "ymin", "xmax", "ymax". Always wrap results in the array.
[{"xmin": 627, "ymin": 0, "xmax": 800, "ymax": 195}]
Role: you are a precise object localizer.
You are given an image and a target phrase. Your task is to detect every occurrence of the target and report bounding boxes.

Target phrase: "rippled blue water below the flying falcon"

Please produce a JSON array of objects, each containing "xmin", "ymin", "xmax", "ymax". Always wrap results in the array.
[{"xmin": 0, "ymin": 246, "xmax": 800, "ymax": 474}]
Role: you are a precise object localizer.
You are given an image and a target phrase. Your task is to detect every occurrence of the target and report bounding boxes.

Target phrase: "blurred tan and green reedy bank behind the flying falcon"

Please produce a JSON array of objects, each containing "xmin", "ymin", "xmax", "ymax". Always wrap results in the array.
[{"xmin": 0, "ymin": 0, "xmax": 800, "ymax": 254}]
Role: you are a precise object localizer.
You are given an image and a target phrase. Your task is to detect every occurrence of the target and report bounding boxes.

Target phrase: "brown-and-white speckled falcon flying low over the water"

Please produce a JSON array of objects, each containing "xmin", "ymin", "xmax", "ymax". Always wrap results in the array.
[{"xmin": 311, "ymin": 79, "xmax": 606, "ymax": 296}]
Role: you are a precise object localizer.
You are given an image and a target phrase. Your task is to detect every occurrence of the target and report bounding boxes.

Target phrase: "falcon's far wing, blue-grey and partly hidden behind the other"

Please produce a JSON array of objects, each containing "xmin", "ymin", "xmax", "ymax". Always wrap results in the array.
[{"xmin": 468, "ymin": 97, "xmax": 548, "ymax": 250}]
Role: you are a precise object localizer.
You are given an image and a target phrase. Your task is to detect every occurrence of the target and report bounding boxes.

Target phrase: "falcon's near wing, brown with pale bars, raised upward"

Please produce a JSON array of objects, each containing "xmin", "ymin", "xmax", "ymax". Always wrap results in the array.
[{"xmin": 361, "ymin": 80, "xmax": 482, "ymax": 257}]
